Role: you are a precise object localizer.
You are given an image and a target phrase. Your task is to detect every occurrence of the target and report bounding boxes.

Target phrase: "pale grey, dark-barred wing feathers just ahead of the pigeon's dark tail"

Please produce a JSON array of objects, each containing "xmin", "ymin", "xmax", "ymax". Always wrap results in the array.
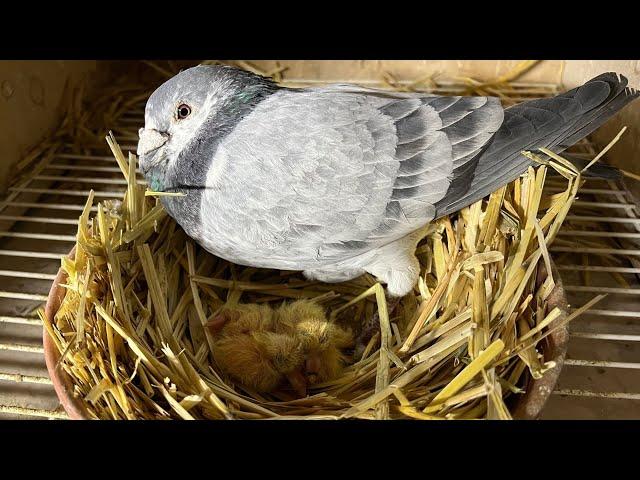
[{"xmin": 362, "ymin": 96, "xmax": 503, "ymax": 242}]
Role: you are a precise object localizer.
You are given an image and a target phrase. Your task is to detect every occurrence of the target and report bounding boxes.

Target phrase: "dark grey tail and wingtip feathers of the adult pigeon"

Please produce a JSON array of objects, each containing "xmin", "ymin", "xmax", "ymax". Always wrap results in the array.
[{"xmin": 436, "ymin": 73, "xmax": 638, "ymax": 217}]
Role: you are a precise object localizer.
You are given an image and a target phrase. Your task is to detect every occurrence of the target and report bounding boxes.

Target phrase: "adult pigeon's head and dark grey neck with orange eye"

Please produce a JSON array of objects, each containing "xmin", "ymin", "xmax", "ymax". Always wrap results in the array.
[{"xmin": 138, "ymin": 65, "xmax": 278, "ymax": 190}]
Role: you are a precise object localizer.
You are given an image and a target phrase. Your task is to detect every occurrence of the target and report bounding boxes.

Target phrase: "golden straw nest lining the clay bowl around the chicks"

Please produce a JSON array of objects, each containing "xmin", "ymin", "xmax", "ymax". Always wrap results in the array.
[{"xmin": 41, "ymin": 127, "xmax": 624, "ymax": 419}]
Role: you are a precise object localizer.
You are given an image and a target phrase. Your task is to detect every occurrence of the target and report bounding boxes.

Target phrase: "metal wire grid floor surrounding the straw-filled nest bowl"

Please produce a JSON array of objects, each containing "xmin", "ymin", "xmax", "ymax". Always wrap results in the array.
[{"xmin": 0, "ymin": 79, "xmax": 640, "ymax": 419}]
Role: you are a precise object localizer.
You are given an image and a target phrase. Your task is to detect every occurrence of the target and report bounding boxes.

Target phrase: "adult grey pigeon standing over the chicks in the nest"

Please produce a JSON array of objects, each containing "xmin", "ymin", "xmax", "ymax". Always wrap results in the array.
[{"xmin": 138, "ymin": 66, "xmax": 638, "ymax": 296}]
